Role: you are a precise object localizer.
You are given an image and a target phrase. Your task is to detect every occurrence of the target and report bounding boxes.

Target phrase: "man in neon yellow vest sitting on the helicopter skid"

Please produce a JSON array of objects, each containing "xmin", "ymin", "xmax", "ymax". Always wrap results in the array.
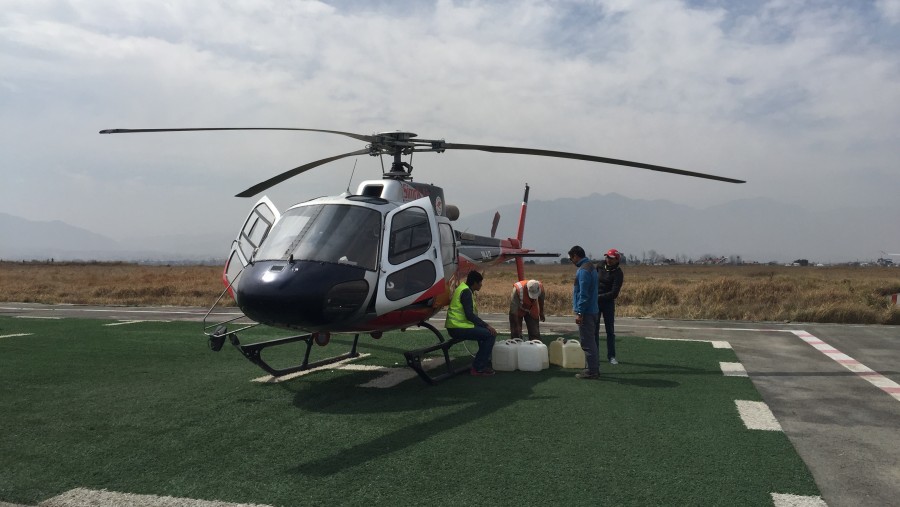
[{"xmin": 444, "ymin": 270, "xmax": 497, "ymax": 376}]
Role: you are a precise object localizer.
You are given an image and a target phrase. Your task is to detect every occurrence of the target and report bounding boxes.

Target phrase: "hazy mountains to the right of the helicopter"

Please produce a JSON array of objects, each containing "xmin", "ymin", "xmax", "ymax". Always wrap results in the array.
[{"xmin": 457, "ymin": 193, "xmax": 900, "ymax": 262}]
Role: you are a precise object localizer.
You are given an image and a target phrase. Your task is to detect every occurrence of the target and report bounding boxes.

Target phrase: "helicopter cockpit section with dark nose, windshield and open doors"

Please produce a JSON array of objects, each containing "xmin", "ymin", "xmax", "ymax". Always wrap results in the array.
[{"xmin": 225, "ymin": 194, "xmax": 456, "ymax": 331}]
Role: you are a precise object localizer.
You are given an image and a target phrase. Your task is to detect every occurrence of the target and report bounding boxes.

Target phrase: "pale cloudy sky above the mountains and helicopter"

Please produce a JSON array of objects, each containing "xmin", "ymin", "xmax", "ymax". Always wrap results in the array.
[{"xmin": 0, "ymin": 0, "xmax": 900, "ymax": 248}]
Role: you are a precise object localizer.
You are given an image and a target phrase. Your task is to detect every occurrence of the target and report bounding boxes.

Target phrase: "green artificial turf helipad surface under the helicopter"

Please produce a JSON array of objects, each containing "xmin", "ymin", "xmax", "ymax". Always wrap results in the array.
[{"xmin": 0, "ymin": 317, "xmax": 819, "ymax": 506}]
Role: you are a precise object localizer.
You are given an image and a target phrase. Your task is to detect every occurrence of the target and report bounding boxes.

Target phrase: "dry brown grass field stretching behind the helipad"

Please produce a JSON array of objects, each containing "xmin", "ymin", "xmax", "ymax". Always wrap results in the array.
[{"xmin": 0, "ymin": 262, "xmax": 900, "ymax": 325}]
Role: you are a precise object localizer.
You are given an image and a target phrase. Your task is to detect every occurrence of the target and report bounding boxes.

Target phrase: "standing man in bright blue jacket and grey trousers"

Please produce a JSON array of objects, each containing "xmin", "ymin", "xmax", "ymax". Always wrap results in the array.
[{"xmin": 569, "ymin": 245, "xmax": 600, "ymax": 379}]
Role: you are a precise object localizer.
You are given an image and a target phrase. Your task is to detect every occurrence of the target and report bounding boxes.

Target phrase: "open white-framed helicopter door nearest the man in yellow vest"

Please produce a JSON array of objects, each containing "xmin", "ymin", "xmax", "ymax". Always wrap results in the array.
[{"xmin": 375, "ymin": 197, "xmax": 444, "ymax": 315}]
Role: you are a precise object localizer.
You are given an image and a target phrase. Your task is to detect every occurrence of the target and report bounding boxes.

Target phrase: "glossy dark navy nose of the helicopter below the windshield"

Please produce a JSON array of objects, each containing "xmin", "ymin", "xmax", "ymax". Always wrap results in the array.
[{"xmin": 237, "ymin": 261, "xmax": 369, "ymax": 331}]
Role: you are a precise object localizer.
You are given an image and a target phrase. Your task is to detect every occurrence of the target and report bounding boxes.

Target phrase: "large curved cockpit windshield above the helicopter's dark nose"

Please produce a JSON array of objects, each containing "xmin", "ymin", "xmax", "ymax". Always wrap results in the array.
[{"xmin": 253, "ymin": 204, "xmax": 381, "ymax": 271}]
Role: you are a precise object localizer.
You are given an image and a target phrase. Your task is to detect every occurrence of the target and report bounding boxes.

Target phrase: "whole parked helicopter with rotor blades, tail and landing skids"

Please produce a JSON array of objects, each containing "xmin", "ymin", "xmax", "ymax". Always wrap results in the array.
[{"xmin": 100, "ymin": 127, "xmax": 744, "ymax": 384}]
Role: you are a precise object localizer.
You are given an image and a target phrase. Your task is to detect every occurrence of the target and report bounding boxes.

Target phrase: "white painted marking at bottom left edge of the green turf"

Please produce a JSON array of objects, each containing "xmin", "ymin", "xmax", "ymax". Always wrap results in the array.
[{"xmin": 41, "ymin": 488, "xmax": 270, "ymax": 507}]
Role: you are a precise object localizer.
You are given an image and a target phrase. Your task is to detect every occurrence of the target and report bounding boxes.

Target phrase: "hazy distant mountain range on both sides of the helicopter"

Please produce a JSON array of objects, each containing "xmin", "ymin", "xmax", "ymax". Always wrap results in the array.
[{"xmin": 0, "ymin": 193, "xmax": 900, "ymax": 263}]
